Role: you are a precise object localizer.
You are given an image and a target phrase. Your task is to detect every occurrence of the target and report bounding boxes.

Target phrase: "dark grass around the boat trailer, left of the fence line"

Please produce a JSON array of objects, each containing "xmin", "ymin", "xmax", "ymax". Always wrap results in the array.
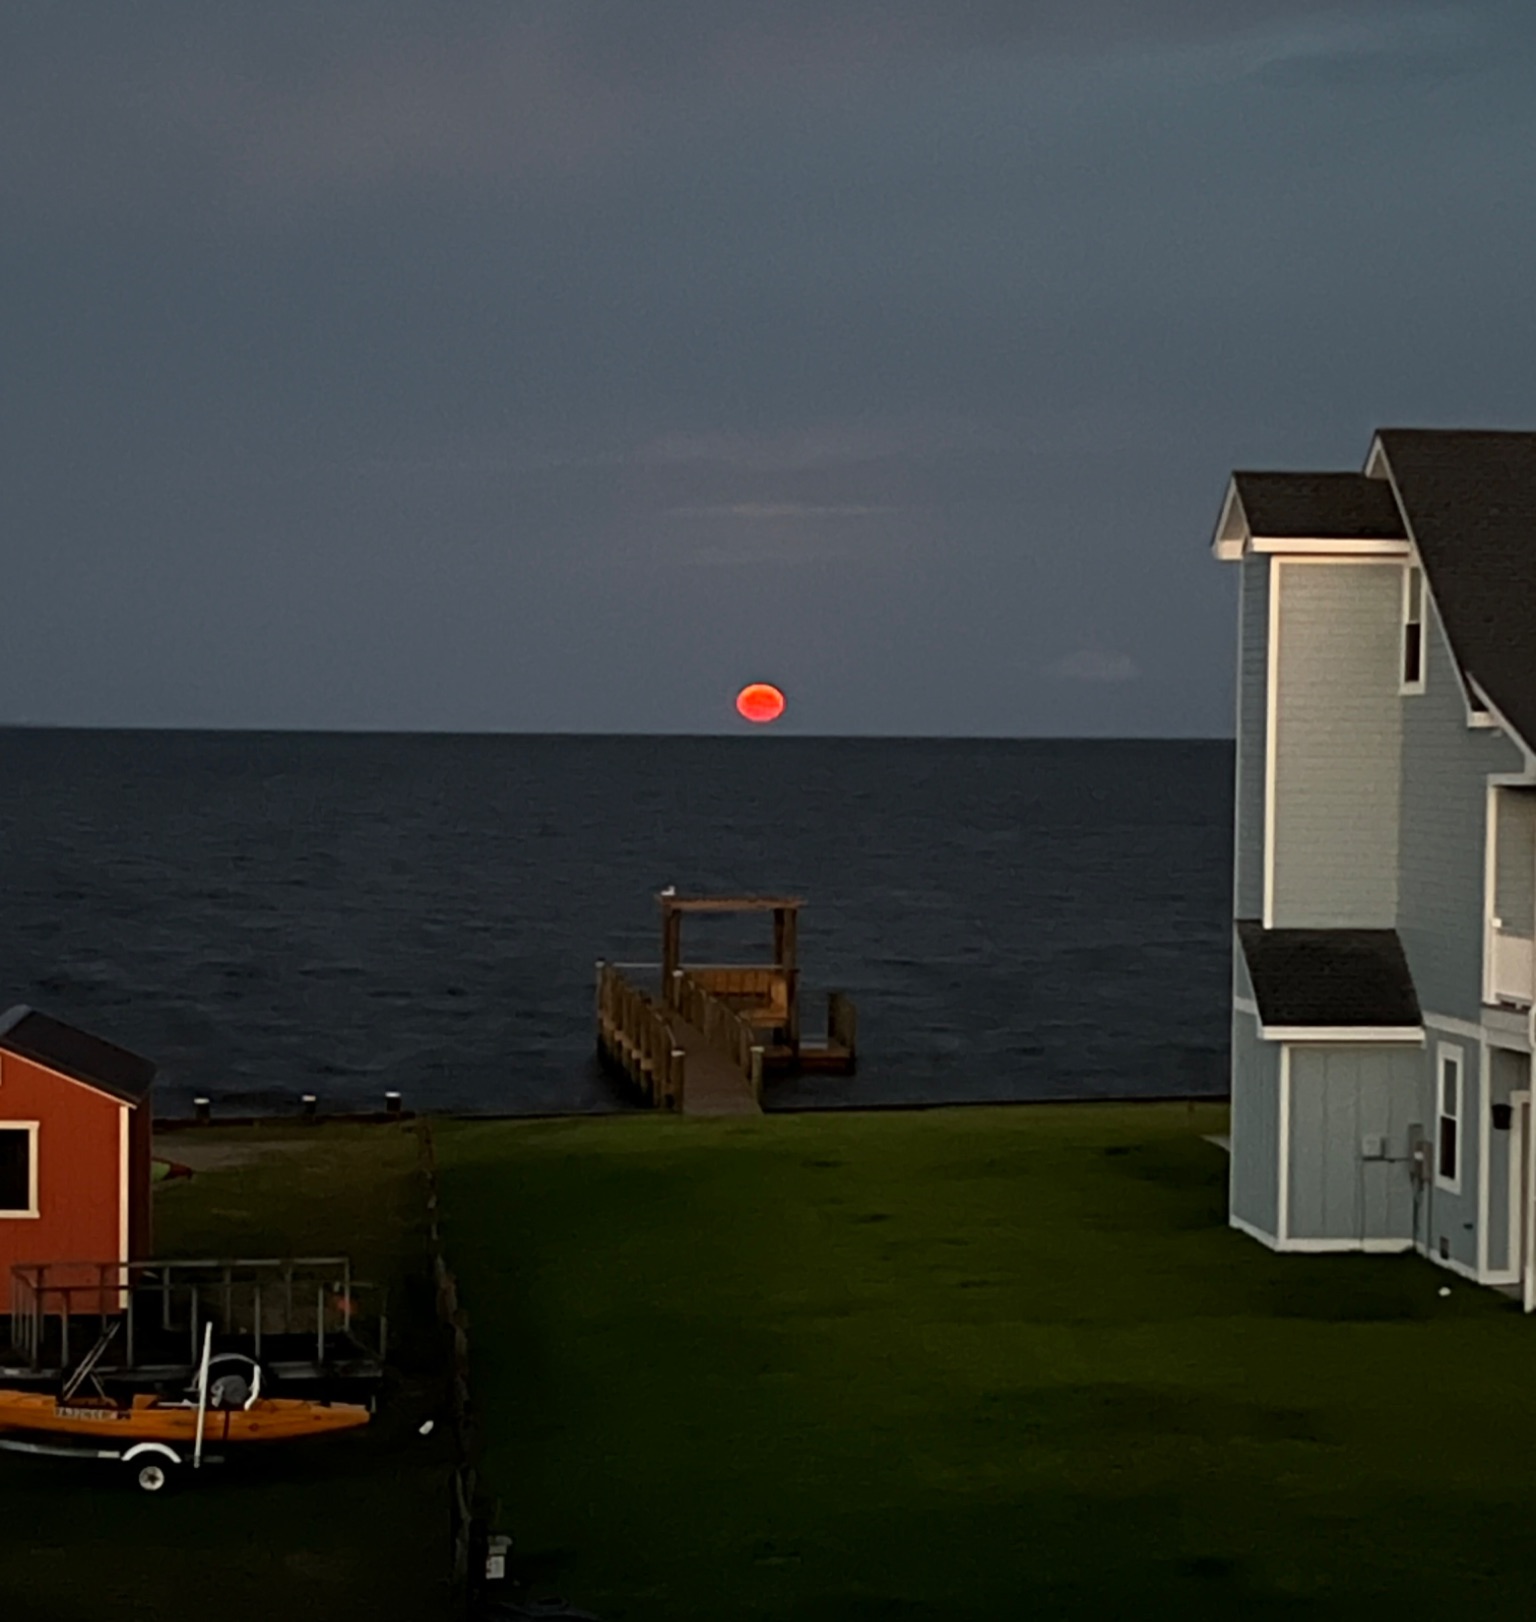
[{"xmin": 0, "ymin": 1126, "xmax": 448, "ymax": 1622}]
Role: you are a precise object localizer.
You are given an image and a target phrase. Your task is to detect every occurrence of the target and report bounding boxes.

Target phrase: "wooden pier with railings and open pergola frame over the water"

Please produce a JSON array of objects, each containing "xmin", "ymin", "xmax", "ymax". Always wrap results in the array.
[{"xmin": 597, "ymin": 895, "xmax": 856, "ymax": 1114}]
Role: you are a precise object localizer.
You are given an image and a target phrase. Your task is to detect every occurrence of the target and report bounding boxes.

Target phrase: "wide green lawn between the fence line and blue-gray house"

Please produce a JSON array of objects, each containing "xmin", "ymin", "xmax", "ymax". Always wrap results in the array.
[{"xmin": 438, "ymin": 1105, "xmax": 1536, "ymax": 1622}]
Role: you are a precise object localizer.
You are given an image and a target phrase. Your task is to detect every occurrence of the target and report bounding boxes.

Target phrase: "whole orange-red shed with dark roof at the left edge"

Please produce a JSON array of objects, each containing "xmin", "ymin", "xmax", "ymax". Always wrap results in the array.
[{"xmin": 0, "ymin": 1007, "xmax": 154, "ymax": 1312}]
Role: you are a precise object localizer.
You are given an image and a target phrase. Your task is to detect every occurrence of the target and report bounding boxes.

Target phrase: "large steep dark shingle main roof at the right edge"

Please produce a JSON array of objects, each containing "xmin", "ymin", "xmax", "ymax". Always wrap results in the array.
[{"xmin": 1379, "ymin": 428, "xmax": 1536, "ymax": 746}]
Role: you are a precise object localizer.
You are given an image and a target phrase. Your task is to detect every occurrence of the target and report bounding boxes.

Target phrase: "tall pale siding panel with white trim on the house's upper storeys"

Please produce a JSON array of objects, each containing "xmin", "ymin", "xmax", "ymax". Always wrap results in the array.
[{"xmin": 1270, "ymin": 560, "xmax": 1403, "ymax": 929}]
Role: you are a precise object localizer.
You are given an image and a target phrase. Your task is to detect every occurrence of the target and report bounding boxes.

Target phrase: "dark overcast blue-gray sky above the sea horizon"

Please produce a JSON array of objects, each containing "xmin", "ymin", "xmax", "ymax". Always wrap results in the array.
[{"xmin": 0, "ymin": 0, "xmax": 1536, "ymax": 735}]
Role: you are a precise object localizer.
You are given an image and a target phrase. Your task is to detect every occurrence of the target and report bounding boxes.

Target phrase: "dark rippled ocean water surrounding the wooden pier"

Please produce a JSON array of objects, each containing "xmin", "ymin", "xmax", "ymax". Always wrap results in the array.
[{"xmin": 0, "ymin": 730, "xmax": 1233, "ymax": 1113}]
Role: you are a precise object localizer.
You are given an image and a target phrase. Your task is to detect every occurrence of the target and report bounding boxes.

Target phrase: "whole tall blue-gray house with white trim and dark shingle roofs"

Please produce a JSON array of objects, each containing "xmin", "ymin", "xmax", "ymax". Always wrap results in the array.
[{"xmin": 1215, "ymin": 428, "xmax": 1536, "ymax": 1311}]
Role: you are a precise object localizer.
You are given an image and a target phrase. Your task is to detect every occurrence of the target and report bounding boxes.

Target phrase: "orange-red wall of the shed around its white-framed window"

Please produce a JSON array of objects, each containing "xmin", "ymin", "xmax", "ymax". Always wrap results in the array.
[{"xmin": 0, "ymin": 1053, "xmax": 136, "ymax": 1312}]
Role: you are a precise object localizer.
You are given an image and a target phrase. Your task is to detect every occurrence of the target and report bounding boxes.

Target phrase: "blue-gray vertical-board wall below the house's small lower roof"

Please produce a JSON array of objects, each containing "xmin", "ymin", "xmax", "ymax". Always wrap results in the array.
[{"xmin": 1286, "ymin": 1045, "xmax": 1422, "ymax": 1247}]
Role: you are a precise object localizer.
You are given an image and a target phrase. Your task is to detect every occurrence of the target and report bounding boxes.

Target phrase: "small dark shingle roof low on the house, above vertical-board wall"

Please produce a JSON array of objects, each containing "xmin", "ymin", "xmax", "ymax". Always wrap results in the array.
[{"xmin": 1238, "ymin": 918, "xmax": 1421, "ymax": 1027}]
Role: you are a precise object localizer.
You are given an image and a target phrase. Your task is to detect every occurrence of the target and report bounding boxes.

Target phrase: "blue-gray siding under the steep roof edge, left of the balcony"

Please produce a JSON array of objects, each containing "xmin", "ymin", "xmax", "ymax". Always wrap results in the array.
[{"xmin": 1397, "ymin": 599, "xmax": 1523, "ymax": 1023}]
